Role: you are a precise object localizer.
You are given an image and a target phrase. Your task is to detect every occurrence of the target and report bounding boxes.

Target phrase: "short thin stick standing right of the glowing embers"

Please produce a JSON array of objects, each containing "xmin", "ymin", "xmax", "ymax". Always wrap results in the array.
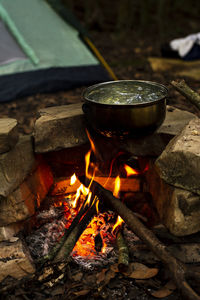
[{"xmin": 116, "ymin": 230, "xmax": 129, "ymax": 272}]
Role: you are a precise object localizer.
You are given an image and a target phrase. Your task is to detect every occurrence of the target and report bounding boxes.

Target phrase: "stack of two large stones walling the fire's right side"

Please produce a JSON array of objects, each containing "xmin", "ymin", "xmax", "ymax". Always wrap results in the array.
[{"xmin": 148, "ymin": 118, "xmax": 200, "ymax": 236}]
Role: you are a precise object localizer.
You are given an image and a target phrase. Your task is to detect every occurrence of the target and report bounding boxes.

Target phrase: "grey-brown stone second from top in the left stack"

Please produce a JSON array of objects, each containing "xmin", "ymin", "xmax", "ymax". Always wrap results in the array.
[{"xmin": 0, "ymin": 136, "xmax": 35, "ymax": 197}]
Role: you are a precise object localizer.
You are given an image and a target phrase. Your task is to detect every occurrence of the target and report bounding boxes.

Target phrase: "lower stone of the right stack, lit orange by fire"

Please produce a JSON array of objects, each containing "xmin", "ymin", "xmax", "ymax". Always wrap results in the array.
[{"xmin": 146, "ymin": 164, "xmax": 200, "ymax": 236}]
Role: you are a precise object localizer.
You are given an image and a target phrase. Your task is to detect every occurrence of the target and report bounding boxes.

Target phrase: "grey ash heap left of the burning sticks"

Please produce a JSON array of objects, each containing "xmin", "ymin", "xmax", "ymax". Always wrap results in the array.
[{"xmin": 26, "ymin": 207, "xmax": 67, "ymax": 259}]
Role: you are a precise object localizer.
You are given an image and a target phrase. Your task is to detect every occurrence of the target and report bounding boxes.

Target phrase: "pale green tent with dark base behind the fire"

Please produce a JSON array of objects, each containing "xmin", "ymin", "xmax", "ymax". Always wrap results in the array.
[{"xmin": 0, "ymin": 0, "xmax": 115, "ymax": 102}]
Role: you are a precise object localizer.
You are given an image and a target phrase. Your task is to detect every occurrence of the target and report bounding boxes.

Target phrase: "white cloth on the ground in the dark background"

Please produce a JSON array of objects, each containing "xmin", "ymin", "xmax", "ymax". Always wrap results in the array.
[{"xmin": 170, "ymin": 32, "xmax": 200, "ymax": 57}]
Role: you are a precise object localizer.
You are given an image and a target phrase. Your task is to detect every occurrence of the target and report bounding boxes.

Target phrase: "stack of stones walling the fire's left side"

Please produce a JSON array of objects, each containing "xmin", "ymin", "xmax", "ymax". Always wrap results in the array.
[{"xmin": 0, "ymin": 118, "xmax": 53, "ymax": 281}]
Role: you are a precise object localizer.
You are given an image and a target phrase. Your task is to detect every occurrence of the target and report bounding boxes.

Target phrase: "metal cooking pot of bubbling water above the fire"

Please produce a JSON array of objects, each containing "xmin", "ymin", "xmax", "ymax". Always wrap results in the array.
[{"xmin": 82, "ymin": 80, "xmax": 168, "ymax": 137}]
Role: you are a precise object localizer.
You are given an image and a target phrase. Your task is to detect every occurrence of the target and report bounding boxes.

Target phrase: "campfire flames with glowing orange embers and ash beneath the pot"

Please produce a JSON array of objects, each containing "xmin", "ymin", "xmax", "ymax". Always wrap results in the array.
[{"xmin": 26, "ymin": 131, "xmax": 148, "ymax": 269}]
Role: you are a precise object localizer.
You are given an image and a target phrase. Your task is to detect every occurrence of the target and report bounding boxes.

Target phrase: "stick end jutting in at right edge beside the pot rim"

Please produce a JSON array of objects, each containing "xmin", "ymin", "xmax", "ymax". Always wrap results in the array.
[{"xmin": 171, "ymin": 80, "xmax": 200, "ymax": 110}]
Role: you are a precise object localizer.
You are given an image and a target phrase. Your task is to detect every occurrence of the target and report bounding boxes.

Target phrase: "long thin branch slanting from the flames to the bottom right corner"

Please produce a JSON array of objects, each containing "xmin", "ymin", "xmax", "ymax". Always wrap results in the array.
[{"xmin": 91, "ymin": 181, "xmax": 200, "ymax": 300}]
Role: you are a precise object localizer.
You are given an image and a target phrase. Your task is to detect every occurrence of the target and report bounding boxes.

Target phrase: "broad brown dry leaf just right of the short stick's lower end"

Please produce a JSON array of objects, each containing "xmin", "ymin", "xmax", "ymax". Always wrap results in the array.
[{"xmin": 125, "ymin": 263, "xmax": 159, "ymax": 279}]
